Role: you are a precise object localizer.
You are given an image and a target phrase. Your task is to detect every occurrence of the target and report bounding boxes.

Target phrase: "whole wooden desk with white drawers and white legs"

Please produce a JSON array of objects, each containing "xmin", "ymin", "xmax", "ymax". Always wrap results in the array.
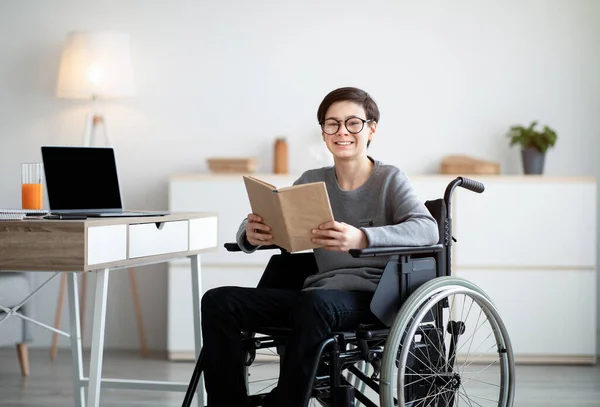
[{"xmin": 0, "ymin": 212, "xmax": 218, "ymax": 407}]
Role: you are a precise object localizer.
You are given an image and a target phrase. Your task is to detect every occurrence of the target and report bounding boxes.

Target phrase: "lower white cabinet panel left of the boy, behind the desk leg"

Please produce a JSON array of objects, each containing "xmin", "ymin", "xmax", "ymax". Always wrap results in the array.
[{"xmin": 167, "ymin": 257, "xmax": 264, "ymax": 360}]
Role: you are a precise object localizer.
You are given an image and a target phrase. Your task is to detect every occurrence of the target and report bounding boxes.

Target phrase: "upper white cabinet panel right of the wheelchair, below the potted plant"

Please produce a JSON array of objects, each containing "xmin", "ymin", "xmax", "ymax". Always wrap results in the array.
[{"xmin": 453, "ymin": 180, "xmax": 597, "ymax": 268}]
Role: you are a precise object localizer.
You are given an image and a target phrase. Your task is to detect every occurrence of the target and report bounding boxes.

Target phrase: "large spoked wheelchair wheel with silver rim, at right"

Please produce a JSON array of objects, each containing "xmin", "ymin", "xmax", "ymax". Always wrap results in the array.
[{"xmin": 380, "ymin": 277, "xmax": 515, "ymax": 407}]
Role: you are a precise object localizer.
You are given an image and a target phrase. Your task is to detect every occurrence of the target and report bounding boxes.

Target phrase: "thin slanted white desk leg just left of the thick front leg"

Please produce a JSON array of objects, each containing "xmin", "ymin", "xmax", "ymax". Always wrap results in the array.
[{"xmin": 63, "ymin": 273, "xmax": 85, "ymax": 407}]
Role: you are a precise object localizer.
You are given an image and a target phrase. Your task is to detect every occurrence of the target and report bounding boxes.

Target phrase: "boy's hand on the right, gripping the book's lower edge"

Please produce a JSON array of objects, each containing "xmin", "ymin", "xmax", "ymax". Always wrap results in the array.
[{"xmin": 312, "ymin": 221, "xmax": 368, "ymax": 252}]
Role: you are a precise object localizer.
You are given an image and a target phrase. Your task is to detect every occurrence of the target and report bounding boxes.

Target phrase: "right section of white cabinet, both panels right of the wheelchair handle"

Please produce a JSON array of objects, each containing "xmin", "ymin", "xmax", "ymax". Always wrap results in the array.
[{"xmin": 452, "ymin": 177, "xmax": 598, "ymax": 363}]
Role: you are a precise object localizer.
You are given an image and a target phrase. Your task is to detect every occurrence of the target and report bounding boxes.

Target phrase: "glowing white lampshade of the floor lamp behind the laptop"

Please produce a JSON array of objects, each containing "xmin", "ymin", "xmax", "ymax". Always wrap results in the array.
[{"xmin": 56, "ymin": 31, "xmax": 135, "ymax": 99}]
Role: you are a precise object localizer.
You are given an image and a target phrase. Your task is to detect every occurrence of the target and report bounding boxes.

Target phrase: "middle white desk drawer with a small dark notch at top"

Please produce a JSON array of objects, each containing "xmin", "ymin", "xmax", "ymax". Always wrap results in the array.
[{"xmin": 129, "ymin": 220, "xmax": 188, "ymax": 259}]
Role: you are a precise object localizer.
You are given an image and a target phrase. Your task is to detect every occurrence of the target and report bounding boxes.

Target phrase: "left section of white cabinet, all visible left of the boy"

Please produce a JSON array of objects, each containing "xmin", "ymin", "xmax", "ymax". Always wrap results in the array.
[{"xmin": 167, "ymin": 175, "xmax": 297, "ymax": 360}]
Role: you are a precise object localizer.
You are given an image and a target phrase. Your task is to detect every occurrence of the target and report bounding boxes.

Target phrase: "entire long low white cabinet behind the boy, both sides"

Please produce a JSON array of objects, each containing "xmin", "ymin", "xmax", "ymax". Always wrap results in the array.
[{"xmin": 167, "ymin": 174, "xmax": 597, "ymax": 362}]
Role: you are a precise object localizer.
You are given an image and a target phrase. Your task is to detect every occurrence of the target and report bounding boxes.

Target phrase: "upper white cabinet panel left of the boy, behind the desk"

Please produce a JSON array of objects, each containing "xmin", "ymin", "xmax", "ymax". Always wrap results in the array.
[{"xmin": 169, "ymin": 175, "xmax": 296, "ymax": 266}]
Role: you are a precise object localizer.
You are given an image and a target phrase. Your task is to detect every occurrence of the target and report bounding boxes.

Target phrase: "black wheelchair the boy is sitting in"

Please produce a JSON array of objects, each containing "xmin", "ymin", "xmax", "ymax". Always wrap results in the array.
[{"xmin": 182, "ymin": 177, "xmax": 515, "ymax": 407}]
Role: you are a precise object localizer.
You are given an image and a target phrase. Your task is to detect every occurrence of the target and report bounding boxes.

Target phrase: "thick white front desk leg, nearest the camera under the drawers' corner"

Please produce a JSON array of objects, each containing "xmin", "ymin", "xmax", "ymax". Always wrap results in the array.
[{"xmin": 87, "ymin": 268, "xmax": 109, "ymax": 407}]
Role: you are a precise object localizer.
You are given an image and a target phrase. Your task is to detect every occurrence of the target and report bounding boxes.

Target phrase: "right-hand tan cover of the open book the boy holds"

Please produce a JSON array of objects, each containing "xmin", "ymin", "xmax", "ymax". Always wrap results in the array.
[{"xmin": 278, "ymin": 182, "xmax": 334, "ymax": 252}]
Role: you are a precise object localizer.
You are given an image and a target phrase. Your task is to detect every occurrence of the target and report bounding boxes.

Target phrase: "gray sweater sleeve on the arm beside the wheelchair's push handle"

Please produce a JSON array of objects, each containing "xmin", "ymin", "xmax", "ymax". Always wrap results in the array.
[{"xmin": 360, "ymin": 171, "xmax": 439, "ymax": 247}]
